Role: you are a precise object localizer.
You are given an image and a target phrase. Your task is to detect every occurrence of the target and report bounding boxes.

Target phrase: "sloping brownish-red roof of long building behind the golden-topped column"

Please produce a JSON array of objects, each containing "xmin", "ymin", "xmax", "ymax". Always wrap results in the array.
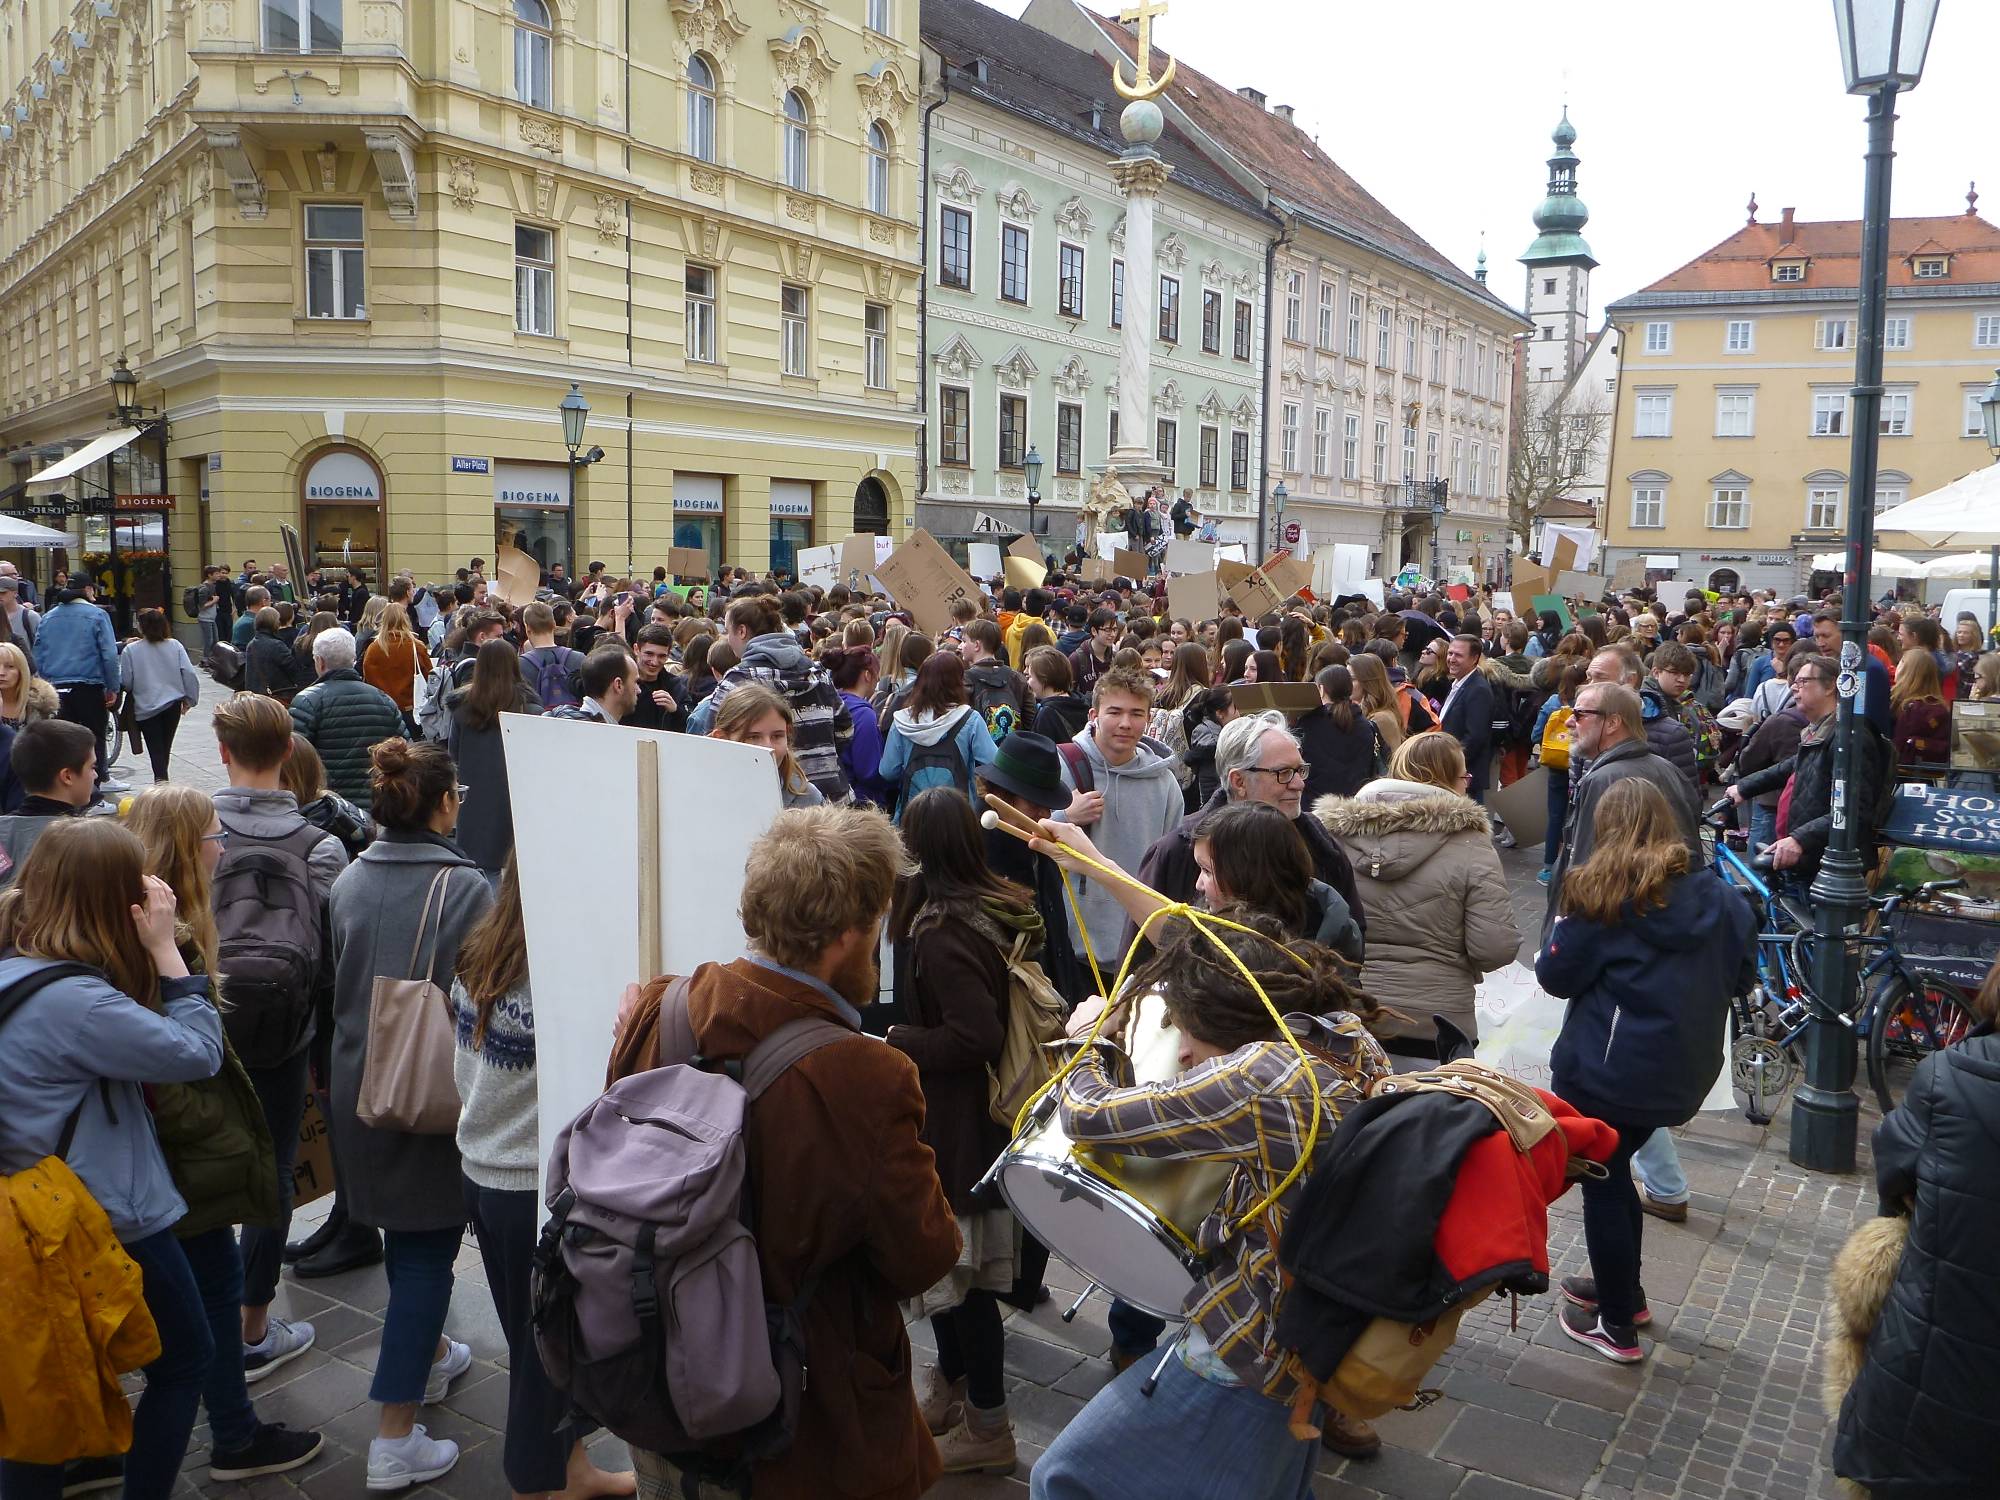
[{"xmin": 1086, "ymin": 12, "xmax": 1526, "ymax": 322}]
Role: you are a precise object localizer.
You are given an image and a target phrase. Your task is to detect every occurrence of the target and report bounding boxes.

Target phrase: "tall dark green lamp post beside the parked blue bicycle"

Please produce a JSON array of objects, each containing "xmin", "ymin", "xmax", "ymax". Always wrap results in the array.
[{"xmin": 1790, "ymin": 0, "xmax": 1938, "ymax": 1172}]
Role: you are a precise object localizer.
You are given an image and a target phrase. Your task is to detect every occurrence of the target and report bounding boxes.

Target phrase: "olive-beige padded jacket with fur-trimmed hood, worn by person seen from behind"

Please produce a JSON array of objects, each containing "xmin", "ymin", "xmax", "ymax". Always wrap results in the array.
[{"xmin": 1312, "ymin": 778, "xmax": 1520, "ymax": 1040}]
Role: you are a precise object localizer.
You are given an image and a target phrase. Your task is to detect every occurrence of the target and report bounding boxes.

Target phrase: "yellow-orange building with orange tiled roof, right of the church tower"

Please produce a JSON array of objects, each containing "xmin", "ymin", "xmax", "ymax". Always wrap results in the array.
[{"xmin": 1604, "ymin": 194, "xmax": 2000, "ymax": 592}]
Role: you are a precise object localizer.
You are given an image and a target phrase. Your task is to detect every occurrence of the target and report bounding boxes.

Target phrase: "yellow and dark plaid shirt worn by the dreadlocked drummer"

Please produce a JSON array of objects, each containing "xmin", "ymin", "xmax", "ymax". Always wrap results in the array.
[{"xmin": 1062, "ymin": 1012, "xmax": 1390, "ymax": 1402}]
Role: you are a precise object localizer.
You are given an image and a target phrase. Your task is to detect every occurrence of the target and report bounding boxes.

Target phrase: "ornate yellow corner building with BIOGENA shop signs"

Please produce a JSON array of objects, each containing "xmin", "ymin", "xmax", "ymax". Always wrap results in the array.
[{"xmin": 0, "ymin": 0, "xmax": 922, "ymax": 624}]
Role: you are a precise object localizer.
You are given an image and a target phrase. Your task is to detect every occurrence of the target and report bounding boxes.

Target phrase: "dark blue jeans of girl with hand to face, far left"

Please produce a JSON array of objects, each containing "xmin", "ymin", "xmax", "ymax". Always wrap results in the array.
[{"xmin": 0, "ymin": 1230, "xmax": 213, "ymax": 1500}]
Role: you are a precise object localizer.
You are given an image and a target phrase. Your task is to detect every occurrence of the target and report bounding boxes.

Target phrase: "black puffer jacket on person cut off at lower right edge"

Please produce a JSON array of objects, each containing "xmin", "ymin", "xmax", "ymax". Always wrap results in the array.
[{"xmin": 1834, "ymin": 1028, "xmax": 2000, "ymax": 1500}]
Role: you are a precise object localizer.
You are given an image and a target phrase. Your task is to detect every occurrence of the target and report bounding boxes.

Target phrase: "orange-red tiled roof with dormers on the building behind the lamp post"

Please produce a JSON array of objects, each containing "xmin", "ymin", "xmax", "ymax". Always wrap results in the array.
[{"xmin": 1638, "ymin": 214, "xmax": 2000, "ymax": 296}]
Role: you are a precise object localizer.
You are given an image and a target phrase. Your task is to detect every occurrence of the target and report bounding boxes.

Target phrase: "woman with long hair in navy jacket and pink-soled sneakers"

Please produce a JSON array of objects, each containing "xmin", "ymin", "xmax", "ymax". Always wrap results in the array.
[{"xmin": 1544, "ymin": 776, "xmax": 1756, "ymax": 1364}]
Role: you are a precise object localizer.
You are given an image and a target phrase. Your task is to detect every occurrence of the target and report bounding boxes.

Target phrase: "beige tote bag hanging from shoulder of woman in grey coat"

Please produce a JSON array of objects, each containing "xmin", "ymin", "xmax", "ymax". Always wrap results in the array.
[{"xmin": 354, "ymin": 866, "xmax": 458, "ymax": 1136}]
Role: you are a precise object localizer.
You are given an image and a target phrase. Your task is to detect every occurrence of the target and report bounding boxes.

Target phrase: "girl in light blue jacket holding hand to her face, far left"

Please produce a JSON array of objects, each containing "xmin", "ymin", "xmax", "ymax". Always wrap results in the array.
[{"xmin": 0, "ymin": 818, "xmax": 222, "ymax": 1500}]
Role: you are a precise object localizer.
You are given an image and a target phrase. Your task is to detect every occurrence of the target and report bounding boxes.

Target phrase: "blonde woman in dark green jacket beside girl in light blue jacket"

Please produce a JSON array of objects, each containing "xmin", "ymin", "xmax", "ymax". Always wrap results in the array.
[{"xmin": 126, "ymin": 786, "xmax": 322, "ymax": 1480}]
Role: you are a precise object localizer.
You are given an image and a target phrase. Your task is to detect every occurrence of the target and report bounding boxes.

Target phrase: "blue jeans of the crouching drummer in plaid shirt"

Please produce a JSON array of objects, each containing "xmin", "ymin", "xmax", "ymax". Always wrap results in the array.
[{"xmin": 1028, "ymin": 1352, "xmax": 1320, "ymax": 1500}]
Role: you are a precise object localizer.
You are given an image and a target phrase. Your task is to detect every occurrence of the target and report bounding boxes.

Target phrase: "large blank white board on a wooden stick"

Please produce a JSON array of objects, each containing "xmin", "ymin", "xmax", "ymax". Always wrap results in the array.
[{"xmin": 500, "ymin": 714, "xmax": 780, "ymax": 1200}]
